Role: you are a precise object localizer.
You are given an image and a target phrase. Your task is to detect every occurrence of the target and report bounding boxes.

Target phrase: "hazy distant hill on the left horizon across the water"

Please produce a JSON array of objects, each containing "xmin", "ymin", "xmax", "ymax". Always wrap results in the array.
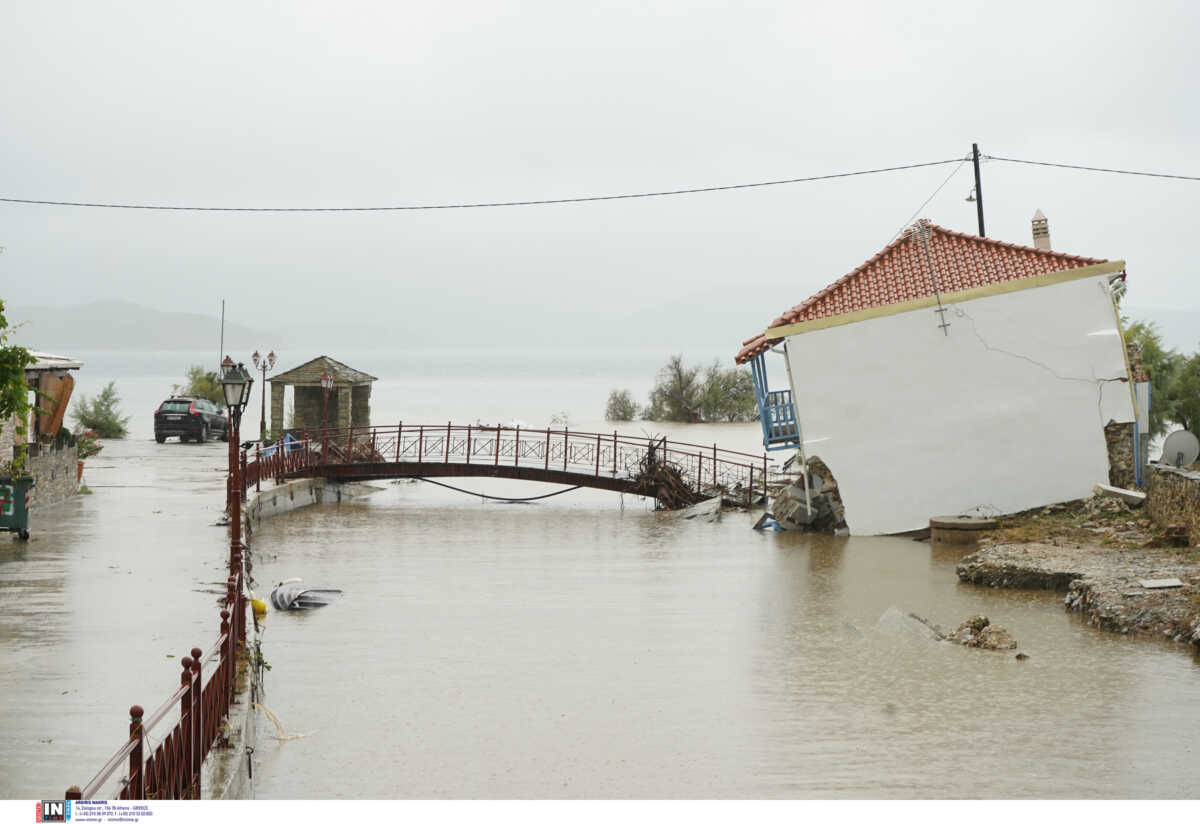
[{"xmin": 5, "ymin": 301, "xmax": 263, "ymax": 354}]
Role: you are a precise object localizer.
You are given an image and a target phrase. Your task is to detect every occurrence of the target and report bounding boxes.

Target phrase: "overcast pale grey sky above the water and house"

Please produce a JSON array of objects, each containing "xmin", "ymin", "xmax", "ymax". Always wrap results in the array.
[{"xmin": 0, "ymin": 0, "xmax": 1200, "ymax": 355}]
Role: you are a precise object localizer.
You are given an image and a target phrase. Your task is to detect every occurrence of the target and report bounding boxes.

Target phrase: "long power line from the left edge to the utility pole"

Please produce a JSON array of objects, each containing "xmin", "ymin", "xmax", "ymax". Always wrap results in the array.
[{"xmin": 0, "ymin": 157, "xmax": 962, "ymax": 212}]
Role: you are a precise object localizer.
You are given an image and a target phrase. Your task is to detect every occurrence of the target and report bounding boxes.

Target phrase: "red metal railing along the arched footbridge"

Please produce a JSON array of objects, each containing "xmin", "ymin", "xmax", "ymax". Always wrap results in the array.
[{"xmin": 242, "ymin": 422, "xmax": 769, "ymax": 504}]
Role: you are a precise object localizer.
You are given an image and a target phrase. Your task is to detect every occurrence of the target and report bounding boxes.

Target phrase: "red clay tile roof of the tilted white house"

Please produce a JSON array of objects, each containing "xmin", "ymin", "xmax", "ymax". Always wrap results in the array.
[{"xmin": 734, "ymin": 221, "xmax": 1105, "ymax": 363}]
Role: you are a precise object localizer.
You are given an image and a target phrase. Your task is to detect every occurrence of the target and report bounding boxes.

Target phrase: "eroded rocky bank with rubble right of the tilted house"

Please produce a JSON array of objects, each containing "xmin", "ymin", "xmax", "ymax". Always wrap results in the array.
[{"xmin": 958, "ymin": 498, "xmax": 1200, "ymax": 646}]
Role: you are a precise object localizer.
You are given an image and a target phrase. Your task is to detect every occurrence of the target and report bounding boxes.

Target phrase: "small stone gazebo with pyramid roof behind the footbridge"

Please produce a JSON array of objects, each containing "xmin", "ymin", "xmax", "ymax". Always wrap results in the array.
[{"xmin": 266, "ymin": 355, "xmax": 378, "ymax": 438}]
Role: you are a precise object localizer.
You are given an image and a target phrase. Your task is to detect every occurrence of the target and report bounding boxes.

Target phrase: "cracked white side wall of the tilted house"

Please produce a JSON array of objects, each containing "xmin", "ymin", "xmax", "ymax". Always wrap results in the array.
[{"xmin": 787, "ymin": 275, "xmax": 1134, "ymax": 535}]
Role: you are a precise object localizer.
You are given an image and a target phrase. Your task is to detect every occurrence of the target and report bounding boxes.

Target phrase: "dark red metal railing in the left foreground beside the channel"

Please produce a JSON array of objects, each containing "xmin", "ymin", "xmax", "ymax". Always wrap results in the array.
[{"xmin": 65, "ymin": 559, "xmax": 246, "ymax": 800}]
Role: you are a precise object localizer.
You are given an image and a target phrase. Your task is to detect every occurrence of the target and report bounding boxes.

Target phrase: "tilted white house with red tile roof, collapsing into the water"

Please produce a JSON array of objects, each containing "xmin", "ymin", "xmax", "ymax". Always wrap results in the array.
[{"xmin": 736, "ymin": 212, "xmax": 1138, "ymax": 535}]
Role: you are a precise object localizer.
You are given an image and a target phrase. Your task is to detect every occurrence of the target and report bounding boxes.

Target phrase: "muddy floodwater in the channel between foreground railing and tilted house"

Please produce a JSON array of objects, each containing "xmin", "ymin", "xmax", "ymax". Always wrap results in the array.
[{"xmin": 256, "ymin": 485, "xmax": 1200, "ymax": 798}]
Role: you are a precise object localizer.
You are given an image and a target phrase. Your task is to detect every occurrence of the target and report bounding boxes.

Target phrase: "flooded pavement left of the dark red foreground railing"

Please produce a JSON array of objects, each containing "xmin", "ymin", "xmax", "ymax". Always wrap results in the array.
[{"xmin": 0, "ymin": 437, "xmax": 229, "ymax": 798}]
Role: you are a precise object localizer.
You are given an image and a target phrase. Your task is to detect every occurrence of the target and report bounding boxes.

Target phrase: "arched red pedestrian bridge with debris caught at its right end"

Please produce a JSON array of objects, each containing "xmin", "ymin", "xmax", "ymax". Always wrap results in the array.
[{"xmin": 242, "ymin": 423, "xmax": 768, "ymax": 507}]
